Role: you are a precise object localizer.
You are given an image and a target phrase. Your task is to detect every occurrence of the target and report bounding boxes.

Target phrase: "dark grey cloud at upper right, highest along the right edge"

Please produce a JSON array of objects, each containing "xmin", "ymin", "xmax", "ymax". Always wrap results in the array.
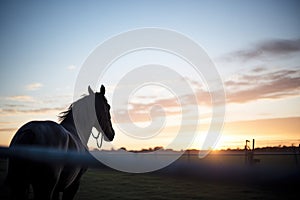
[{"xmin": 225, "ymin": 38, "xmax": 300, "ymax": 61}]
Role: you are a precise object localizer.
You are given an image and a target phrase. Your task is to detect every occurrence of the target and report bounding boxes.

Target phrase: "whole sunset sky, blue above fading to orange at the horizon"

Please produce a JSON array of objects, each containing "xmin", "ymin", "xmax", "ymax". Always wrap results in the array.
[{"xmin": 0, "ymin": 0, "xmax": 300, "ymax": 149}]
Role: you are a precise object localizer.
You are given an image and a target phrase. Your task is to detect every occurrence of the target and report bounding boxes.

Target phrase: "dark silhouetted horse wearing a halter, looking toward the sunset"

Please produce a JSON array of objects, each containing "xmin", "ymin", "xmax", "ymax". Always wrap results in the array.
[{"xmin": 7, "ymin": 85, "xmax": 115, "ymax": 200}]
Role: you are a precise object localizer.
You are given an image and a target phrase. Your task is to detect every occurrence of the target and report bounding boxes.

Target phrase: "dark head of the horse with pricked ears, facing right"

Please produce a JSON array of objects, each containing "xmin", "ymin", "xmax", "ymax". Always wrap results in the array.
[{"xmin": 88, "ymin": 85, "xmax": 115, "ymax": 141}]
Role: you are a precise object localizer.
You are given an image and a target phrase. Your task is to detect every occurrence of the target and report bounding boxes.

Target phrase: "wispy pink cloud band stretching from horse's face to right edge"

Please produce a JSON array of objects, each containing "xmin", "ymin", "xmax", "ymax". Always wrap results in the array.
[{"xmin": 114, "ymin": 67, "xmax": 300, "ymax": 123}]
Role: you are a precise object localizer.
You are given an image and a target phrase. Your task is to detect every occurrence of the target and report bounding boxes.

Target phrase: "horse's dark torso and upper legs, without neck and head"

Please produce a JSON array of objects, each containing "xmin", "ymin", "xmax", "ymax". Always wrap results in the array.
[{"xmin": 8, "ymin": 121, "xmax": 86, "ymax": 199}]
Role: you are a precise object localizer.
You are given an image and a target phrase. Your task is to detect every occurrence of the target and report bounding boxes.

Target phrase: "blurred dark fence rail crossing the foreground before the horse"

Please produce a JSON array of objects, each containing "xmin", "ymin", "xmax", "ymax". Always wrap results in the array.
[{"xmin": 0, "ymin": 147, "xmax": 300, "ymax": 183}]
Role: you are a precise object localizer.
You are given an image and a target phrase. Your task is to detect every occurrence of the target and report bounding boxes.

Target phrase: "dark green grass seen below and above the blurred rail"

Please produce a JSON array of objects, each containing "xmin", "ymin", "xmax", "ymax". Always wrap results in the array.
[{"xmin": 0, "ymin": 152, "xmax": 300, "ymax": 200}]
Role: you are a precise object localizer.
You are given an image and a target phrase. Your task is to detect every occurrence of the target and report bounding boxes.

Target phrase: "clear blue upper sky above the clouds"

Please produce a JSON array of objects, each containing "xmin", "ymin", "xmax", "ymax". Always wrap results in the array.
[{"xmin": 0, "ymin": 1, "xmax": 300, "ymax": 95}]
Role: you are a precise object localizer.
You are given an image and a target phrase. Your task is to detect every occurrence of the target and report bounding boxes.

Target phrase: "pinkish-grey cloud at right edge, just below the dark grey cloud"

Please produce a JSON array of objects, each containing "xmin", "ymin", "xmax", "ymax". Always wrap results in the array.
[{"xmin": 225, "ymin": 68, "xmax": 300, "ymax": 103}]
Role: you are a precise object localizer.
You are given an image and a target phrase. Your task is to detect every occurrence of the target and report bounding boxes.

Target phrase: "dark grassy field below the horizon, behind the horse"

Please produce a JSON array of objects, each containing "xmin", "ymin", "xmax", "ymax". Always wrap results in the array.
[{"xmin": 0, "ymin": 152, "xmax": 300, "ymax": 200}]
